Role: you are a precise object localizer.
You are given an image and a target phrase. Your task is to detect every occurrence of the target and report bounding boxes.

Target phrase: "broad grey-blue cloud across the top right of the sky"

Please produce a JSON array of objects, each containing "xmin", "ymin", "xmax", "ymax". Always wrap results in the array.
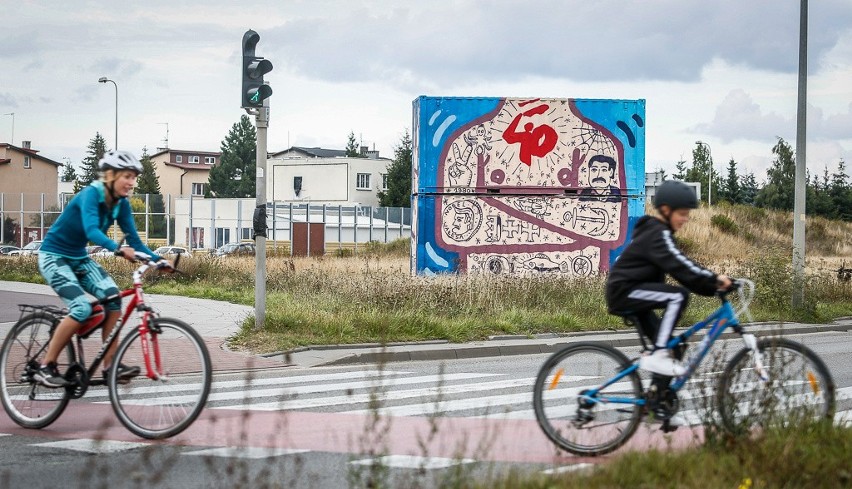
[{"xmin": 264, "ymin": 0, "xmax": 852, "ymax": 86}]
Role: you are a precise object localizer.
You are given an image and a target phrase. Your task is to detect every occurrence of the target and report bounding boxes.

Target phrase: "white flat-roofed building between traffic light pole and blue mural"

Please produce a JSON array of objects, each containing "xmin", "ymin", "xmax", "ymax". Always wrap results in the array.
[{"xmin": 266, "ymin": 146, "xmax": 392, "ymax": 207}]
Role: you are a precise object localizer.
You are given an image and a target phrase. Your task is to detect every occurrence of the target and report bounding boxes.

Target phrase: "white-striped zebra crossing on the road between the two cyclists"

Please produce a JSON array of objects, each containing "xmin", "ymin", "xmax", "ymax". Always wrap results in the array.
[{"xmin": 78, "ymin": 369, "xmax": 852, "ymax": 425}]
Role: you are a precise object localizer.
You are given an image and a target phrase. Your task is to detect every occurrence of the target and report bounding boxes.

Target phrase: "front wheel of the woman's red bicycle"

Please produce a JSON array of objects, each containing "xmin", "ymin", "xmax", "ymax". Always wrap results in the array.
[{"xmin": 107, "ymin": 318, "xmax": 212, "ymax": 439}]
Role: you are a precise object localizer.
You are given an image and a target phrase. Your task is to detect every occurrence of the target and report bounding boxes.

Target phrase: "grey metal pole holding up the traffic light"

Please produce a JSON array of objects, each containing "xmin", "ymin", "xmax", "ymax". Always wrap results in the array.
[{"xmin": 254, "ymin": 98, "xmax": 269, "ymax": 329}]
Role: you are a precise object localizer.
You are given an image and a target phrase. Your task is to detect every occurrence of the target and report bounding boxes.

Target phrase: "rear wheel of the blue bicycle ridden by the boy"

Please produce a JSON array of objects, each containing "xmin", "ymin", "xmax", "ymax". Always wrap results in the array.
[{"xmin": 533, "ymin": 343, "xmax": 642, "ymax": 455}]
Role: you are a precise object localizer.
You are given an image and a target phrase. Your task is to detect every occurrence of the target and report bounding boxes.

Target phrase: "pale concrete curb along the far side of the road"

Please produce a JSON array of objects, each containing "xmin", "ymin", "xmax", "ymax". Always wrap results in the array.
[{"xmin": 274, "ymin": 323, "xmax": 852, "ymax": 367}]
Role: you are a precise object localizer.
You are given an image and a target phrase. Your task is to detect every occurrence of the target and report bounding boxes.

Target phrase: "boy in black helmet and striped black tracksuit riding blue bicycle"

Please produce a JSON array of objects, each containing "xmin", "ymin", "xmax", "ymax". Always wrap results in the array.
[{"xmin": 606, "ymin": 180, "xmax": 731, "ymax": 377}]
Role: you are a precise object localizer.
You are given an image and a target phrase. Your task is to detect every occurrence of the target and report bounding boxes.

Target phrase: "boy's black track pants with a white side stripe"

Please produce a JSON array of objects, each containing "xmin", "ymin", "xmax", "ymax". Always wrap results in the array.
[{"xmin": 618, "ymin": 283, "xmax": 689, "ymax": 348}]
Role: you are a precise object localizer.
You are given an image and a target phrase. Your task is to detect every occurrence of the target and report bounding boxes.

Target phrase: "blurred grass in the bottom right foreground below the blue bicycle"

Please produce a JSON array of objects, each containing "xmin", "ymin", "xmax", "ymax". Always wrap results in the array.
[{"xmin": 476, "ymin": 423, "xmax": 852, "ymax": 489}]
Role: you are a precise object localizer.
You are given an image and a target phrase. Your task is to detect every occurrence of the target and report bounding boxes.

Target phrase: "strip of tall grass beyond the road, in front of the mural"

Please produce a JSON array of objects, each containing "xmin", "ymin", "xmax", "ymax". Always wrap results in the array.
[{"xmin": 0, "ymin": 245, "xmax": 852, "ymax": 353}]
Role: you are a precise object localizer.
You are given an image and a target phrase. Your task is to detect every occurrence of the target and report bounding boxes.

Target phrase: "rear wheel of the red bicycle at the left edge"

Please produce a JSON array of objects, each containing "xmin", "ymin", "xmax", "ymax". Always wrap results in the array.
[{"xmin": 0, "ymin": 313, "xmax": 76, "ymax": 429}]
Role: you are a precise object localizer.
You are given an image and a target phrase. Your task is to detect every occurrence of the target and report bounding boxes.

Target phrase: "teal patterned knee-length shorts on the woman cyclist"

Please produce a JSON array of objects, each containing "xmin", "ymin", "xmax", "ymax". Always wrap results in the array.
[{"xmin": 38, "ymin": 251, "xmax": 121, "ymax": 322}]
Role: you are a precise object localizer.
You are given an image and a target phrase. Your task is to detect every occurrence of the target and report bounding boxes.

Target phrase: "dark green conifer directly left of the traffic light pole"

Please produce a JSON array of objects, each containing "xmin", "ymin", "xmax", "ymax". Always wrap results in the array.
[{"xmin": 205, "ymin": 114, "xmax": 257, "ymax": 198}]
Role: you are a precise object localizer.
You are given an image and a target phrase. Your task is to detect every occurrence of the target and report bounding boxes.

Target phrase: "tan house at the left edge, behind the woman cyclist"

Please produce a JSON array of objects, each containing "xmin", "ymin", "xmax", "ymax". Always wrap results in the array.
[{"xmin": 0, "ymin": 141, "xmax": 63, "ymax": 245}]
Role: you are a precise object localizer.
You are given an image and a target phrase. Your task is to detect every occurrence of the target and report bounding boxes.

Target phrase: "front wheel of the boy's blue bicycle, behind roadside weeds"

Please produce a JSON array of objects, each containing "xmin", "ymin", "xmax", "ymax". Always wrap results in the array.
[{"xmin": 717, "ymin": 338, "xmax": 835, "ymax": 435}]
